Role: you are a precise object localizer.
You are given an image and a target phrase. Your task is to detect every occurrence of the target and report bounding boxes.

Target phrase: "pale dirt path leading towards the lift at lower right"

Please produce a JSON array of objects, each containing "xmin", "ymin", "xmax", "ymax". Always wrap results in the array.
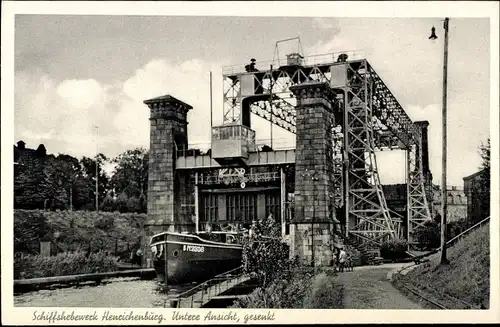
[{"xmin": 337, "ymin": 266, "xmax": 422, "ymax": 309}]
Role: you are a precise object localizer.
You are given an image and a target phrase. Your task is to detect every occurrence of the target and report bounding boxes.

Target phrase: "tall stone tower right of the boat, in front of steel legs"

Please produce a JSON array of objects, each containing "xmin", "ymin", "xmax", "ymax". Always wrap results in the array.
[{"xmin": 290, "ymin": 83, "xmax": 336, "ymax": 266}]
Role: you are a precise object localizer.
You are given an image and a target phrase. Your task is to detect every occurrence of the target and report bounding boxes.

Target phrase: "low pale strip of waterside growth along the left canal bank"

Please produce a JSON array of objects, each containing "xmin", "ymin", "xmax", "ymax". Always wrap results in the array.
[{"xmin": 14, "ymin": 252, "xmax": 118, "ymax": 279}]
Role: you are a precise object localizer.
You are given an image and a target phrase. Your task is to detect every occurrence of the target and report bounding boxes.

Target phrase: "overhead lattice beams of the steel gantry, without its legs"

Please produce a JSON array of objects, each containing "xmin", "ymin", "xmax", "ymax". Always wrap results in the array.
[{"xmin": 223, "ymin": 54, "xmax": 420, "ymax": 148}]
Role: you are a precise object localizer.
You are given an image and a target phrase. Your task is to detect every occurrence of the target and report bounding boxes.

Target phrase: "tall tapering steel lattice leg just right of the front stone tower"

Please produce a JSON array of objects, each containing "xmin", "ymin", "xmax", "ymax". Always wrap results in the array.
[{"xmin": 344, "ymin": 61, "xmax": 397, "ymax": 246}]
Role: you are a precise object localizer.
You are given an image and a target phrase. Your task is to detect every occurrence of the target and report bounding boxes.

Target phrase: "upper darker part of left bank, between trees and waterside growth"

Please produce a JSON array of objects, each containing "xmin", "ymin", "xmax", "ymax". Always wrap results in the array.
[{"xmin": 14, "ymin": 210, "xmax": 147, "ymax": 259}]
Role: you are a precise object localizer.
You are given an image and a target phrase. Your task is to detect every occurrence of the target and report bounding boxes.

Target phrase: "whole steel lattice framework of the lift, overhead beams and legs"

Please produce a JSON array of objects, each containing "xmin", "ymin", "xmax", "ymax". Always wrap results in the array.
[{"xmin": 223, "ymin": 53, "xmax": 431, "ymax": 247}]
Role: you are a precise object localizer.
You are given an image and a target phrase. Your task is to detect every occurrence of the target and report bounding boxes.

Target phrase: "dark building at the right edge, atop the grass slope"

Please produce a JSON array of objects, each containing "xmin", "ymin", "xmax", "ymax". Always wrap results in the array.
[{"xmin": 464, "ymin": 169, "xmax": 490, "ymax": 222}]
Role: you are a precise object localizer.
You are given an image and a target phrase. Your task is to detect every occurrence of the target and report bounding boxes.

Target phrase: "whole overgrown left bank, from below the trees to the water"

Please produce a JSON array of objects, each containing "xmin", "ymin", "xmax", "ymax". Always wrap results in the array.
[{"xmin": 14, "ymin": 210, "xmax": 147, "ymax": 279}]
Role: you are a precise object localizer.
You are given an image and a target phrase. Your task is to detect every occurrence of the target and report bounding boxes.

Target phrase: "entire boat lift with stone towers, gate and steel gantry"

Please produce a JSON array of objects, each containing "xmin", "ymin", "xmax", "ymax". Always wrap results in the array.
[{"xmin": 144, "ymin": 39, "xmax": 432, "ymax": 272}]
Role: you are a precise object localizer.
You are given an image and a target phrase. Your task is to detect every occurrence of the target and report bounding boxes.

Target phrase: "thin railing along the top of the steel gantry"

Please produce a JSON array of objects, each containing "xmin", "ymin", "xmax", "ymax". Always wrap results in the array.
[{"xmin": 222, "ymin": 50, "xmax": 366, "ymax": 75}]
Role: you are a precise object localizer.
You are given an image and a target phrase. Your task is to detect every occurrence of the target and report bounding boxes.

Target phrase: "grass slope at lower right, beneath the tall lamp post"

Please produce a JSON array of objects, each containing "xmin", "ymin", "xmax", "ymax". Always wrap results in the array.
[{"xmin": 396, "ymin": 224, "xmax": 490, "ymax": 309}]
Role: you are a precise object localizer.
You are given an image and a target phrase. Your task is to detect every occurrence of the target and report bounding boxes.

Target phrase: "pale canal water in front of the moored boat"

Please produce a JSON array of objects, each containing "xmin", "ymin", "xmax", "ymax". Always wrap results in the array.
[{"xmin": 14, "ymin": 278, "xmax": 195, "ymax": 308}]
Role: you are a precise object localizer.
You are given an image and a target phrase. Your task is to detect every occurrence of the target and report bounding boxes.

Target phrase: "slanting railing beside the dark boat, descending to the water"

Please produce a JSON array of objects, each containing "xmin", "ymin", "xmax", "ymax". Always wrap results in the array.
[{"xmin": 171, "ymin": 266, "xmax": 246, "ymax": 308}]
